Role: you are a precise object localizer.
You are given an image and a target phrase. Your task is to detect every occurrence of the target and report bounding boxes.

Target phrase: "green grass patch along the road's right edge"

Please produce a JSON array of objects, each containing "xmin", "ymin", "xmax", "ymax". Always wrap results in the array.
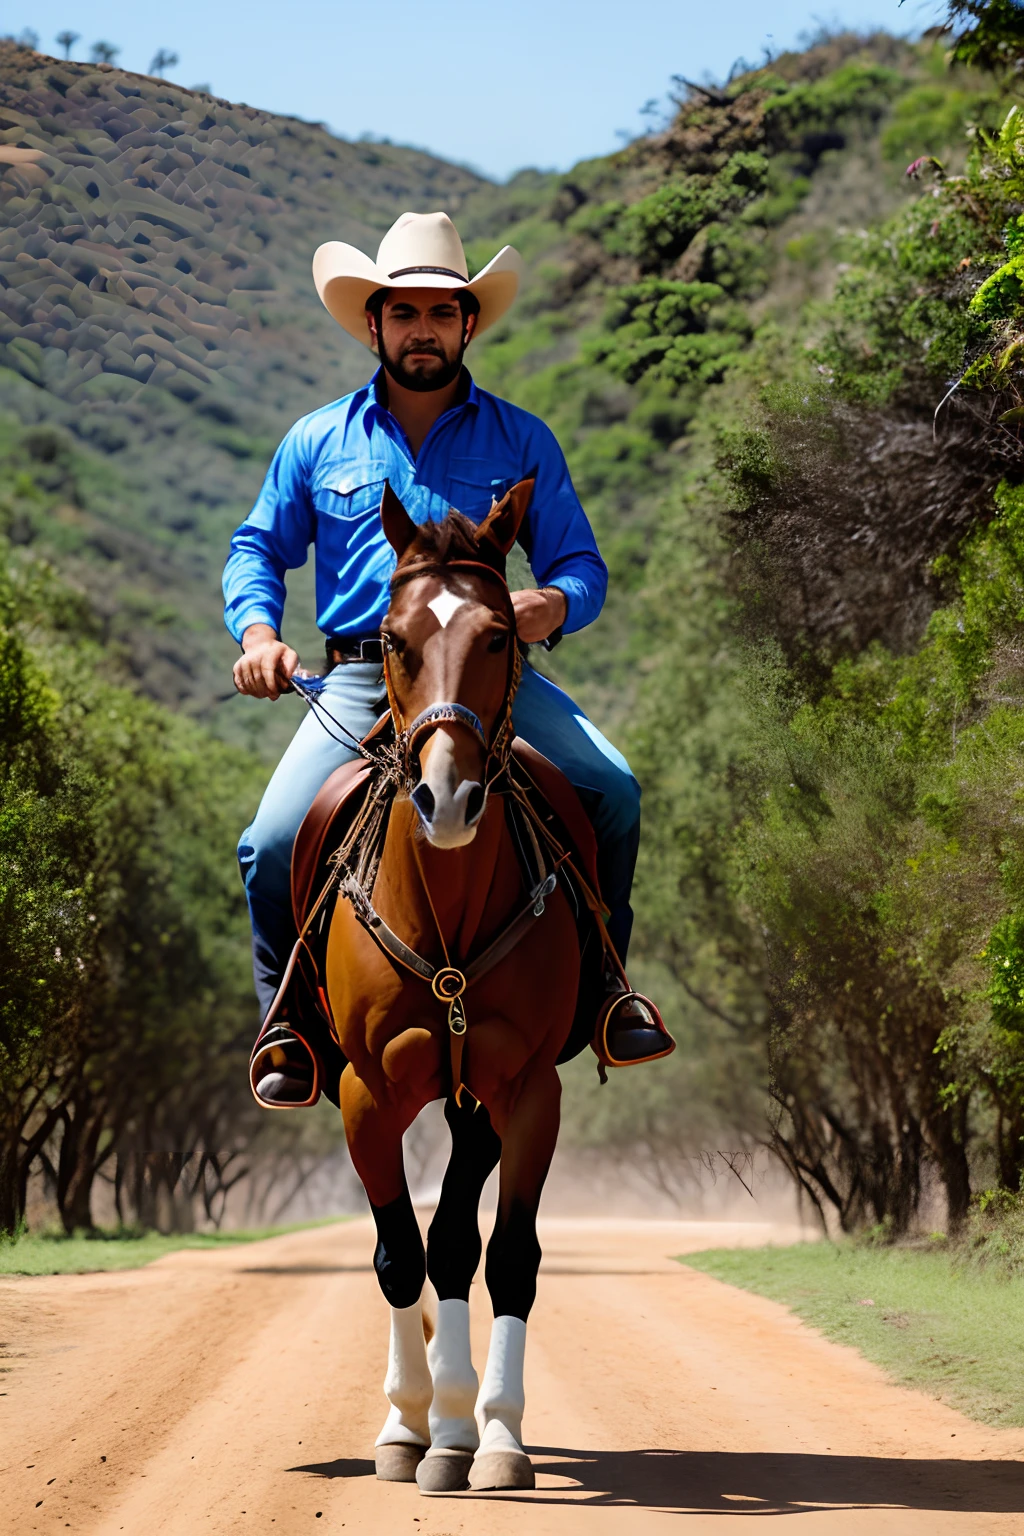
[{"xmin": 680, "ymin": 1243, "xmax": 1024, "ymax": 1428}]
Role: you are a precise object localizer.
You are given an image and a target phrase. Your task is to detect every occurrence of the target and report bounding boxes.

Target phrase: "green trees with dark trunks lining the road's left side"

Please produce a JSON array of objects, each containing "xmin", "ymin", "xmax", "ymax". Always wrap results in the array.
[{"xmin": 0, "ymin": 528, "xmax": 268, "ymax": 1232}]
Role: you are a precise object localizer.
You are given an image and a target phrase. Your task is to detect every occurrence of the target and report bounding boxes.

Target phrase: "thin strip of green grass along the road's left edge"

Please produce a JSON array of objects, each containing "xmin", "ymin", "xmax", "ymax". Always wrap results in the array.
[{"xmin": 0, "ymin": 1217, "xmax": 347, "ymax": 1275}]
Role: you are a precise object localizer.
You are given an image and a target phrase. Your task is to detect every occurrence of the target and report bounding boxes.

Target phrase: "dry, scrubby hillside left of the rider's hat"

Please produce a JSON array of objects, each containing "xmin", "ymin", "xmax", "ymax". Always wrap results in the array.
[{"xmin": 0, "ymin": 43, "xmax": 481, "ymax": 737}]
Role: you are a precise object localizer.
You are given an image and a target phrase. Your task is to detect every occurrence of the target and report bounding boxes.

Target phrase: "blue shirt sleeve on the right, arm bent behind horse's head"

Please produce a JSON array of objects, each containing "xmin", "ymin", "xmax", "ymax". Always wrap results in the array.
[{"xmin": 520, "ymin": 421, "xmax": 608, "ymax": 634}]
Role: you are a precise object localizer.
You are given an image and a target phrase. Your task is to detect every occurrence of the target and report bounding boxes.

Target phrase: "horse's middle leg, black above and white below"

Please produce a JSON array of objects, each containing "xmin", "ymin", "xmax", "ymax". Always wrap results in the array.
[{"xmin": 416, "ymin": 1098, "xmax": 502, "ymax": 1493}]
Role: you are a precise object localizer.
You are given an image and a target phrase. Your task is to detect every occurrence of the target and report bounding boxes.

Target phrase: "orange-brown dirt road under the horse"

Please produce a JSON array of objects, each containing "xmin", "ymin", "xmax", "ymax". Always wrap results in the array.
[{"xmin": 0, "ymin": 1220, "xmax": 1024, "ymax": 1536}]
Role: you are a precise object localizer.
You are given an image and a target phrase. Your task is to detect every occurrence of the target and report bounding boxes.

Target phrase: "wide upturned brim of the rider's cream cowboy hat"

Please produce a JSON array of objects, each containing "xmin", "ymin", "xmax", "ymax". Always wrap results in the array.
[{"xmin": 313, "ymin": 240, "xmax": 522, "ymax": 347}]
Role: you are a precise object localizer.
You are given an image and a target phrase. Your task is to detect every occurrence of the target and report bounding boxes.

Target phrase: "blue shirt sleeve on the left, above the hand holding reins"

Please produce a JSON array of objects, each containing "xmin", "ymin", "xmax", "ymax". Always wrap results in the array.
[{"xmin": 223, "ymin": 422, "xmax": 316, "ymax": 642}]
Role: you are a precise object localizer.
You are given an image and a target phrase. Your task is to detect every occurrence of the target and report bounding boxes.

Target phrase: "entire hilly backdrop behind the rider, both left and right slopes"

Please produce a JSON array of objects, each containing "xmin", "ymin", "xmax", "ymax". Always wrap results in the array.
[{"xmin": 0, "ymin": 27, "xmax": 994, "ymax": 751}]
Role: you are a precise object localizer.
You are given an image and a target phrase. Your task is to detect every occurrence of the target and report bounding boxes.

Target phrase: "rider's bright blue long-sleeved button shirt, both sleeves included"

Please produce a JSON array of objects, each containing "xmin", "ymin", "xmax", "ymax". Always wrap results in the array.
[{"xmin": 224, "ymin": 369, "xmax": 608, "ymax": 641}]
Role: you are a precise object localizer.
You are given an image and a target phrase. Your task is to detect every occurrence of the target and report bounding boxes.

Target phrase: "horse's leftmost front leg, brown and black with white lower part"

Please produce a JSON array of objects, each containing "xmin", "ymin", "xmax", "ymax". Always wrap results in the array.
[{"xmin": 341, "ymin": 1068, "xmax": 433, "ymax": 1482}]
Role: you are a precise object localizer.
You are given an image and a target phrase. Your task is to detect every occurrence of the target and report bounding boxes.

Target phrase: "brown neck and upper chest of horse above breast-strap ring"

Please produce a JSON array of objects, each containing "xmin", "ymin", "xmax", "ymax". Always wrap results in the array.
[{"xmin": 375, "ymin": 796, "xmax": 520, "ymax": 965}]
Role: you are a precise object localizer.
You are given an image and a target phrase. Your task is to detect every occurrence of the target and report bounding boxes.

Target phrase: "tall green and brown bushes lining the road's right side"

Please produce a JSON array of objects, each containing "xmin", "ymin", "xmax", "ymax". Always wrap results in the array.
[{"xmin": 626, "ymin": 12, "xmax": 1024, "ymax": 1233}]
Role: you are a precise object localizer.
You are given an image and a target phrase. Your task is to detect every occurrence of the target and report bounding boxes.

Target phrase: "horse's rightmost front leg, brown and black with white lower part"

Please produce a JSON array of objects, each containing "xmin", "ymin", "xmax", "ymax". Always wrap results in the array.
[{"xmin": 470, "ymin": 1064, "xmax": 562, "ymax": 1488}]
